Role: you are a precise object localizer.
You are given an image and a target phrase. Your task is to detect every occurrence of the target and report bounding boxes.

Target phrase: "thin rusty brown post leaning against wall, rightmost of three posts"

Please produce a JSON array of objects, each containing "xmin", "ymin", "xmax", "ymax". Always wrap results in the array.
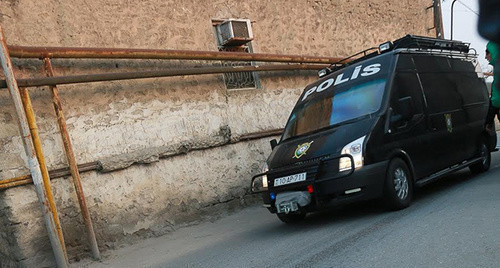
[{"xmin": 43, "ymin": 58, "xmax": 101, "ymax": 260}]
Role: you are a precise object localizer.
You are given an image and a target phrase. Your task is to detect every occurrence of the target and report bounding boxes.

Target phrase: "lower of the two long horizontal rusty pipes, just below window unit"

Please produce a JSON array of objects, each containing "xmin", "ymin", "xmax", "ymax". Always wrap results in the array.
[{"xmin": 0, "ymin": 64, "xmax": 328, "ymax": 88}]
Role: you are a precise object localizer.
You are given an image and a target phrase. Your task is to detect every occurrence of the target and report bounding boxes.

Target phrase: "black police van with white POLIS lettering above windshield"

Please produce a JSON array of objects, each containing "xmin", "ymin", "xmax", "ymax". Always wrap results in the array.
[{"xmin": 251, "ymin": 35, "xmax": 496, "ymax": 222}]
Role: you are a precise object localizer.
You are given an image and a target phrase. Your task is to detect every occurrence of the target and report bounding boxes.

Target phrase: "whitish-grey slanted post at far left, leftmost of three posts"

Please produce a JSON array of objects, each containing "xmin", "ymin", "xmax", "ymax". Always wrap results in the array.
[{"xmin": 0, "ymin": 26, "xmax": 68, "ymax": 267}]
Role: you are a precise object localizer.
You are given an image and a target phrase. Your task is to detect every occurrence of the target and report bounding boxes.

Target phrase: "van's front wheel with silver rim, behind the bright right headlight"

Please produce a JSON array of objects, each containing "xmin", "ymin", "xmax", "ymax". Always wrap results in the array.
[{"xmin": 384, "ymin": 158, "xmax": 413, "ymax": 210}]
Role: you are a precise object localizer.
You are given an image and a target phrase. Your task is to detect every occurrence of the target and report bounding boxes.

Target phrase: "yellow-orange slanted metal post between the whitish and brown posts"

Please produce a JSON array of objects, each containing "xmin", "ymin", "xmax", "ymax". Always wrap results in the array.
[{"xmin": 20, "ymin": 88, "xmax": 68, "ymax": 260}]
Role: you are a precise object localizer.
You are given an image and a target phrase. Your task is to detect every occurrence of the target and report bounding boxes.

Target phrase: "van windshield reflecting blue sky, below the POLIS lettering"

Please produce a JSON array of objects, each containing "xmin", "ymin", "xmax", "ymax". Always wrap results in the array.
[{"xmin": 283, "ymin": 78, "xmax": 386, "ymax": 140}]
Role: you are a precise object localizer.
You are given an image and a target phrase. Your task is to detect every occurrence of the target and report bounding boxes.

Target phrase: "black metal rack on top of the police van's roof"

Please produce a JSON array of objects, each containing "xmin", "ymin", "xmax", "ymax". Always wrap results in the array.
[{"xmin": 391, "ymin": 34, "xmax": 470, "ymax": 53}]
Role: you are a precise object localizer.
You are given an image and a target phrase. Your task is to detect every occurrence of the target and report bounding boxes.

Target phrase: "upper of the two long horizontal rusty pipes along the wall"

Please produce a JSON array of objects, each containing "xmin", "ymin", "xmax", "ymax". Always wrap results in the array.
[{"xmin": 9, "ymin": 46, "xmax": 343, "ymax": 64}]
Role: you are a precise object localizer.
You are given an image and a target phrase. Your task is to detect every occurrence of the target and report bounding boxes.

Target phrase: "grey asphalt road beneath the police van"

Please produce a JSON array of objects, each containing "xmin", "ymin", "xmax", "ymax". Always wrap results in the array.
[{"xmin": 85, "ymin": 152, "xmax": 500, "ymax": 267}]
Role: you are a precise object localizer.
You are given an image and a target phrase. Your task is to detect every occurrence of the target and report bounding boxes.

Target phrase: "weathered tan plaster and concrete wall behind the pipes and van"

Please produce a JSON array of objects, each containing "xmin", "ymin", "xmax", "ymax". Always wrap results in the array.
[{"xmin": 0, "ymin": 0, "xmax": 435, "ymax": 267}]
